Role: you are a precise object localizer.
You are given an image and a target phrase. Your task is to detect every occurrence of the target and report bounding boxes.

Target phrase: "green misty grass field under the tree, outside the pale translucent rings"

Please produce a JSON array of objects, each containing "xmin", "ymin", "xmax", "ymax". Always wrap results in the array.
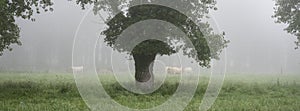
[{"xmin": 0, "ymin": 73, "xmax": 300, "ymax": 111}]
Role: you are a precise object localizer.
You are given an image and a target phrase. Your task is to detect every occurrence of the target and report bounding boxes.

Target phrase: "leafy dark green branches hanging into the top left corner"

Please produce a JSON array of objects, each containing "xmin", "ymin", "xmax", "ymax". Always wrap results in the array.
[{"xmin": 0, "ymin": 0, "xmax": 53, "ymax": 56}]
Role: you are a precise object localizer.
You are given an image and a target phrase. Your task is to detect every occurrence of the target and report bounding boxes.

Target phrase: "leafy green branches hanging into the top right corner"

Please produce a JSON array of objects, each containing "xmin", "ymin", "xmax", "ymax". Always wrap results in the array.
[{"xmin": 273, "ymin": 0, "xmax": 300, "ymax": 49}]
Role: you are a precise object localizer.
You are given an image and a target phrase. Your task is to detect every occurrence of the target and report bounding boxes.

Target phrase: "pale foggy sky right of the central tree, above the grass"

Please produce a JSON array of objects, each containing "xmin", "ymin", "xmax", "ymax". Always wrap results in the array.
[{"xmin": 212, "ymin": 0, "xmax": 300, "ymax": 73}]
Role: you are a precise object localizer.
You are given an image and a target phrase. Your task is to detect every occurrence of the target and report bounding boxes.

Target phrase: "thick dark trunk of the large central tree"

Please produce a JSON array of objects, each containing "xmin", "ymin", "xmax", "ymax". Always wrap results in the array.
[{"xmin": 133, "ymin": 54, "xmax": 156, "ymax": 89}]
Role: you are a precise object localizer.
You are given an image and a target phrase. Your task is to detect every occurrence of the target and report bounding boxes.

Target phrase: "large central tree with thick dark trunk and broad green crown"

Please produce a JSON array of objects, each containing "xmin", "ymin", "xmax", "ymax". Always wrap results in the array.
[{"xmin": 77, "ymin": 0, "xmax": 229, "ymax": 86}]
